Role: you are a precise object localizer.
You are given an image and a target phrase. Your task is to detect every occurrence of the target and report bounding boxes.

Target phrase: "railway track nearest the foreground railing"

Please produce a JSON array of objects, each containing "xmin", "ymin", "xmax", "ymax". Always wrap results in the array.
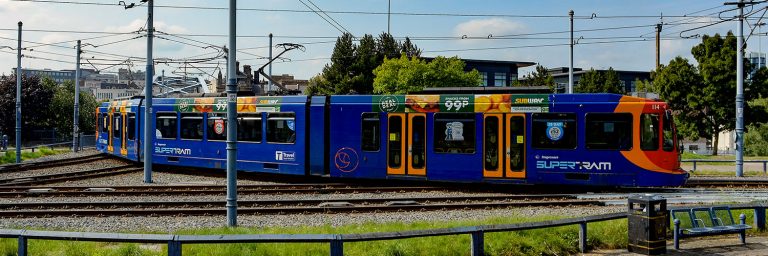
[{"xmin": 0, "ymin": 195, "xmax": 603, "ymax": 218}]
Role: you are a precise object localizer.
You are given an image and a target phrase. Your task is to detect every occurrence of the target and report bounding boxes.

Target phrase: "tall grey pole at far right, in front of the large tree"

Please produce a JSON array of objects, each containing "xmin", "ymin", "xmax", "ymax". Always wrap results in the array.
[{"xmin": 736, "ymin": 0, "xmax": 744, "ymax": 177}]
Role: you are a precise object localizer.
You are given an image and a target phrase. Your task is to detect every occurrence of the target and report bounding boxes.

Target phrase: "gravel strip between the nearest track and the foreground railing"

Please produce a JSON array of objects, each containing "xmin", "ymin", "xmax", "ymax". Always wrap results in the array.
[{"xmin": 0, "ymin": 206, "xmax": 626, "ymax": 233}]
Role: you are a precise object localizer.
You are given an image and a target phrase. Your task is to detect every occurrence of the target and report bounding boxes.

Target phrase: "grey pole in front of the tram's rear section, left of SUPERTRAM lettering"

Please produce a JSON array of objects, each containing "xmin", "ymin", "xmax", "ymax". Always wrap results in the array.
[{"xmin": 144, "ymin": 0, "xmax": 155, "ymax": 183}]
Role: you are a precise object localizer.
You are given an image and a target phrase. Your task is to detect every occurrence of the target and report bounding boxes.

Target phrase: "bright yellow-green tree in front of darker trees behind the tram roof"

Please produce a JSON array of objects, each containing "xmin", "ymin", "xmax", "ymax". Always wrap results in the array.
[{"xmin": 373, "ymin": 54, "xmax": 482, "ymax": 94}]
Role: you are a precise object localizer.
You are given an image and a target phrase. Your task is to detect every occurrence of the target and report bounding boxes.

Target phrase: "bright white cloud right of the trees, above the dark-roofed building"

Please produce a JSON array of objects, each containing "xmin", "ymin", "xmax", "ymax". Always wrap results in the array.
[{"xmin": 453, "ymin": 18, "xmax": 527, "ymax": 37}]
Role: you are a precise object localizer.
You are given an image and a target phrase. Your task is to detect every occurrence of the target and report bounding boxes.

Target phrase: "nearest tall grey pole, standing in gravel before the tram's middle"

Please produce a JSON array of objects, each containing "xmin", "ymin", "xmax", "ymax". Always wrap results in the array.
[{"xmin": 227, "ymin": 0, "xmax": 238, "ymax": 227}]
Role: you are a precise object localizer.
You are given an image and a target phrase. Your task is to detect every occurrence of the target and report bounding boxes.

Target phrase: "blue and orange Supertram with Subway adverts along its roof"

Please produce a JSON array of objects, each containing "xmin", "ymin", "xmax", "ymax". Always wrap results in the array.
[{"xmin": 97, "ymin": 94, "xmax": 688, "ymax": 186}]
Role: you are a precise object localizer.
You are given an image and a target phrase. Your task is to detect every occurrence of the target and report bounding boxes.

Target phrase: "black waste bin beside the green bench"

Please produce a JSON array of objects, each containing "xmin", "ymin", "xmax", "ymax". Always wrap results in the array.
[{"xmin": 627, "ymin": 194, "xmax": 668, "ymax": 255}]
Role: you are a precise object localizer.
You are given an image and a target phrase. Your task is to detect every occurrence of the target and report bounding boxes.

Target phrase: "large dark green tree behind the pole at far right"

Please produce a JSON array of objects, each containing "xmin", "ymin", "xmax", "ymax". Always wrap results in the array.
[{"xmin": 653, "ymin": 32, "xmax": 768, "ymax": 154}]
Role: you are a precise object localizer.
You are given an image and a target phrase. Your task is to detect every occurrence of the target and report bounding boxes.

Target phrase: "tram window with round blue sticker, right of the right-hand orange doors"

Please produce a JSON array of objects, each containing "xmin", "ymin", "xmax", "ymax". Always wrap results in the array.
[{"xmin": 531, "ymin": 113, "xmax": 577, "ymax": 149}]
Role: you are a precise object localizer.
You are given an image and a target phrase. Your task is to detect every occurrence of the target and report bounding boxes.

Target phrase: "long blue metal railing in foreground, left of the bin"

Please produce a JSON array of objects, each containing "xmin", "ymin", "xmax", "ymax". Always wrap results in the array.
[{"xmin": 0, "ymin": 212, "xmax": 627, "ymax": 256}]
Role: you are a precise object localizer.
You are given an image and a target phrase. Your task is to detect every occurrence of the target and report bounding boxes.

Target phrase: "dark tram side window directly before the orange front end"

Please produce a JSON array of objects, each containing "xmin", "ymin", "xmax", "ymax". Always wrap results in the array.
[{"xmin": 584, "ymin": 113, "xmax": 632, "ymax": 151}]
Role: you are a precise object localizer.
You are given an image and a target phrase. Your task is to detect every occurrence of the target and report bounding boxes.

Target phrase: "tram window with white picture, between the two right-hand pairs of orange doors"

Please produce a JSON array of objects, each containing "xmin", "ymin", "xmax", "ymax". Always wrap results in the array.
[{"xmin": 433, "ymin": 113, "xmax": 475, "ymax": 154}]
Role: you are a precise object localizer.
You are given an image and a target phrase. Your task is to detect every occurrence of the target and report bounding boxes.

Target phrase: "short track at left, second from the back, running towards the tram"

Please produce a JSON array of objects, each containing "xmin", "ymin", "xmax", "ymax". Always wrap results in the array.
[{"xmin": 0, "ymin": 164, "xmax": 142, "ymax": 187}]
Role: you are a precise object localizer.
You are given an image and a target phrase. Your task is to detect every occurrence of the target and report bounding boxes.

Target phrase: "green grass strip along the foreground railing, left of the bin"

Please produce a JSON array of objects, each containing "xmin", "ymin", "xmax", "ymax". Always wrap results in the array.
[{"xmin": 0, "ymin": 216, "xmax": 627, "ymax": 256}]
